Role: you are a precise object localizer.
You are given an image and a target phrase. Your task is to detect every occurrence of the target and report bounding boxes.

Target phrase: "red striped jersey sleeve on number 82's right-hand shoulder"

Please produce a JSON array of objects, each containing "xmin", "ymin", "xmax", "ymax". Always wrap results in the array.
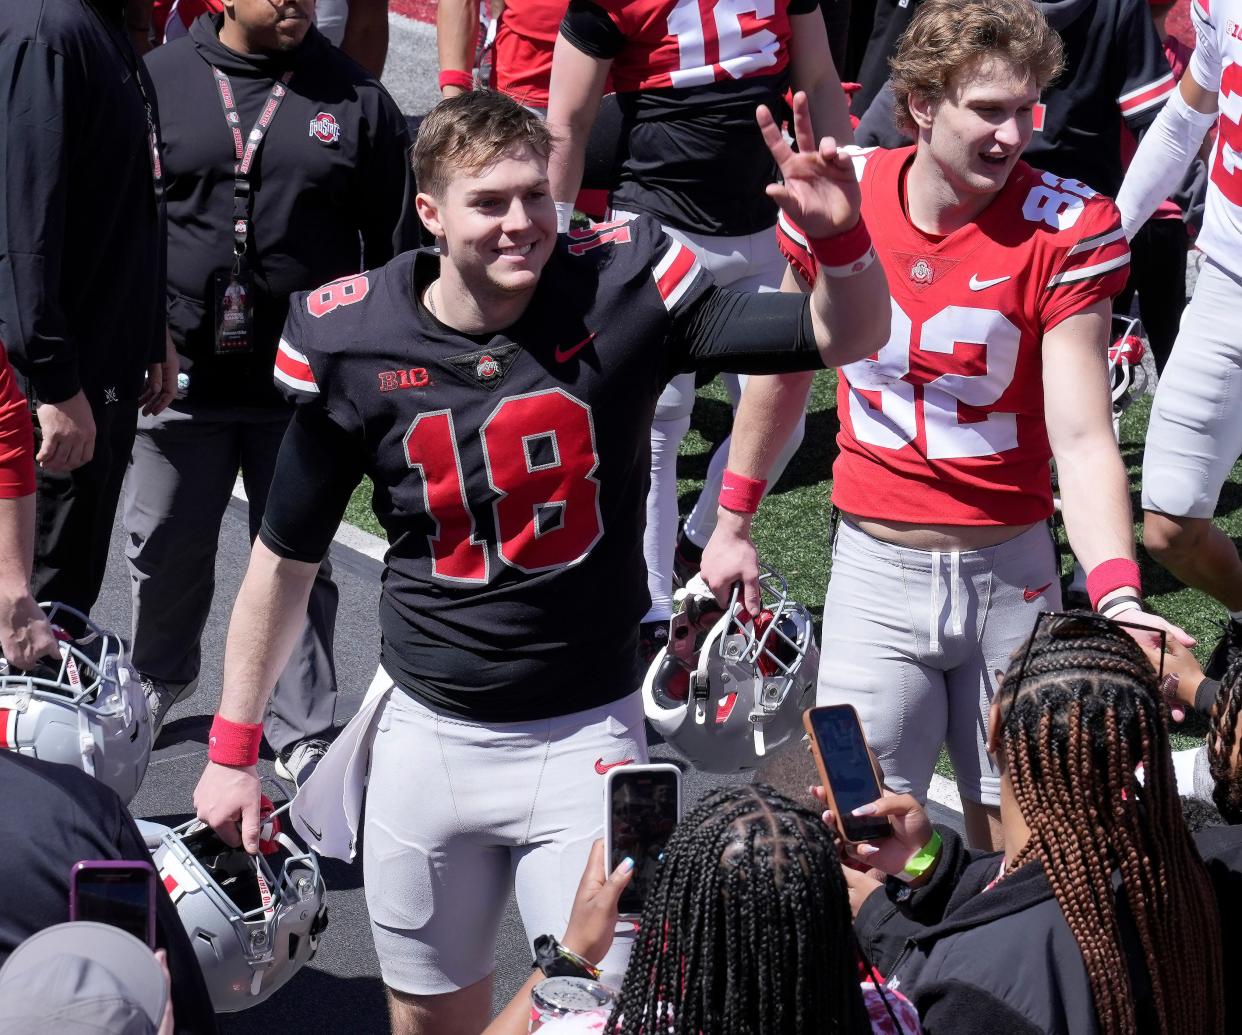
[{"xmin": 1042, "ymin": 194, "xmax": 1130, "ymax": 332}]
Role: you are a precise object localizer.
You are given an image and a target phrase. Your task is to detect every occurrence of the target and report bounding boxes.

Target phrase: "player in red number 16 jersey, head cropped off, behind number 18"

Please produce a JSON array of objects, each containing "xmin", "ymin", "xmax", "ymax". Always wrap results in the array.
[{"xmin": 548, "ymin": 0, "xmax": 852, "ymax": 655}]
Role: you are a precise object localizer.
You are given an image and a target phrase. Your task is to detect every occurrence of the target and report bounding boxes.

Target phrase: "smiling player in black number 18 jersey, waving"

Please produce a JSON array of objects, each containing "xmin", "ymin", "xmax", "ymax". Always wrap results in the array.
[{"xmin": 195, "ymin": 92, "xmax": 889, "ymax": 1035}]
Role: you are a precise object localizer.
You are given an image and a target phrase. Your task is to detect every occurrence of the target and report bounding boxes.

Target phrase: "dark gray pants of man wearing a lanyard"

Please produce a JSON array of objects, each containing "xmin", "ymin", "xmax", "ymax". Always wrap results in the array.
[{"xmin": 124, "ymin": 404, "xmax": 337, "ymax": 750}]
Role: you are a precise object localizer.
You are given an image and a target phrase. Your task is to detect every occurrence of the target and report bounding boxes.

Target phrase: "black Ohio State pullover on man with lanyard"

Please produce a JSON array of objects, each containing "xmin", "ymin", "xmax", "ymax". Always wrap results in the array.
[{"xmin": 147, "ymin": 15, "xmax": 417, "ymax": 406}]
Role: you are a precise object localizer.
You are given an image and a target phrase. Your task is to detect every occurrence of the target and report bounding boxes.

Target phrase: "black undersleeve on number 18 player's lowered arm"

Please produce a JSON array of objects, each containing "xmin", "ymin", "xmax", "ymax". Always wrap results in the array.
[{"xmin": 258, "ymin": 406, "xmax": 363, "ymax": 564}]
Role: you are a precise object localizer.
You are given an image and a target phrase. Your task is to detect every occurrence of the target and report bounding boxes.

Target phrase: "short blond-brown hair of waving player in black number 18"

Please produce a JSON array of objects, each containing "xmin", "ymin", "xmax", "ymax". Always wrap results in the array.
[{"xmin": 414, "ymin": 89, "xmax": 551, "ymax": 198}]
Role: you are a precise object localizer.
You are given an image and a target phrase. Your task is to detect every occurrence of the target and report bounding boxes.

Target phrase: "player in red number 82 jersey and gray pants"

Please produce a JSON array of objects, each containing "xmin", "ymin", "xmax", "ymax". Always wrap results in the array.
[{"xmin": 703, "ymin": 0, "xmax": 1184, "ymax": 845}]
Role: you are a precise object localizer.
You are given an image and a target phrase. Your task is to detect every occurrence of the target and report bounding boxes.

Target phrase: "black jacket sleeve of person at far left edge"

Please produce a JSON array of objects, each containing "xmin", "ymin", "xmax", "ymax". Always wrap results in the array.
[{"xmin": 0, "ymin": 40, "xmax": 86, "ymax": 403}]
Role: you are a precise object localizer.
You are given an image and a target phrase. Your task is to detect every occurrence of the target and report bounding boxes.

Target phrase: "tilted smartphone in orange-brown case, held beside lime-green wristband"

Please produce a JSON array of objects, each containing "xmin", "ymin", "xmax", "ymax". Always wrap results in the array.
[{"xmin": 802, "ymin": 704, "xmax": 893, "ymax": 845}]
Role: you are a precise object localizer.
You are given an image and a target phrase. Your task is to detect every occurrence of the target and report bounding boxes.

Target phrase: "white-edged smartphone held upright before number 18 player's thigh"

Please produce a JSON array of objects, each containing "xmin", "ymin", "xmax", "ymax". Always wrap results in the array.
[{"xmin": 604, "ymin": 763, "xmax": 682, "ymax": 916}]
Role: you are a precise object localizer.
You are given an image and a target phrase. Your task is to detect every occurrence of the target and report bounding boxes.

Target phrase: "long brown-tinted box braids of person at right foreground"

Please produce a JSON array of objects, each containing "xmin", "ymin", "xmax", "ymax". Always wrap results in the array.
[{"xmin": 999, "ymin": 619, "xmax": 1225, "ymax": 1035}]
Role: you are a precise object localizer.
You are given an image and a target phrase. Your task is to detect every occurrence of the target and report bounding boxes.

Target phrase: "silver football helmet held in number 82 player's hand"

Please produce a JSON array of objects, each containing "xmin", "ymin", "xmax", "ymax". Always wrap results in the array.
[{"xmin": 642, "ymin": 568, "xmax": 820, "ymax": 773}]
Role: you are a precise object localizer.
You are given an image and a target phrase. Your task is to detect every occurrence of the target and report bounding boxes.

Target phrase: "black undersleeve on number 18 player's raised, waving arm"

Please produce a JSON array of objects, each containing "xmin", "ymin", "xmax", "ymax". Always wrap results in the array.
[{"xmin": 673, "ymin": 286, "xmax": 823, "ymax": 374}]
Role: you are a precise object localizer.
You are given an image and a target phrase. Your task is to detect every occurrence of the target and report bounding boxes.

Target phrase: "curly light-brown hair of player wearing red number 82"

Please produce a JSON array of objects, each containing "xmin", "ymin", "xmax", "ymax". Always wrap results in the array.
[{"xmin": 888, "ymin": 0, "xmax": 1063, "ymax": 134}]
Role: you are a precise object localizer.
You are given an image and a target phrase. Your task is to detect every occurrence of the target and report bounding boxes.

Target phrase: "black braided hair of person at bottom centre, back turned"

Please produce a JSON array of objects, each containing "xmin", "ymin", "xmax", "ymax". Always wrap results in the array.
[{"xmin": 605, "ymin": 784, "xmax": 871, "ymax": 1035}]
